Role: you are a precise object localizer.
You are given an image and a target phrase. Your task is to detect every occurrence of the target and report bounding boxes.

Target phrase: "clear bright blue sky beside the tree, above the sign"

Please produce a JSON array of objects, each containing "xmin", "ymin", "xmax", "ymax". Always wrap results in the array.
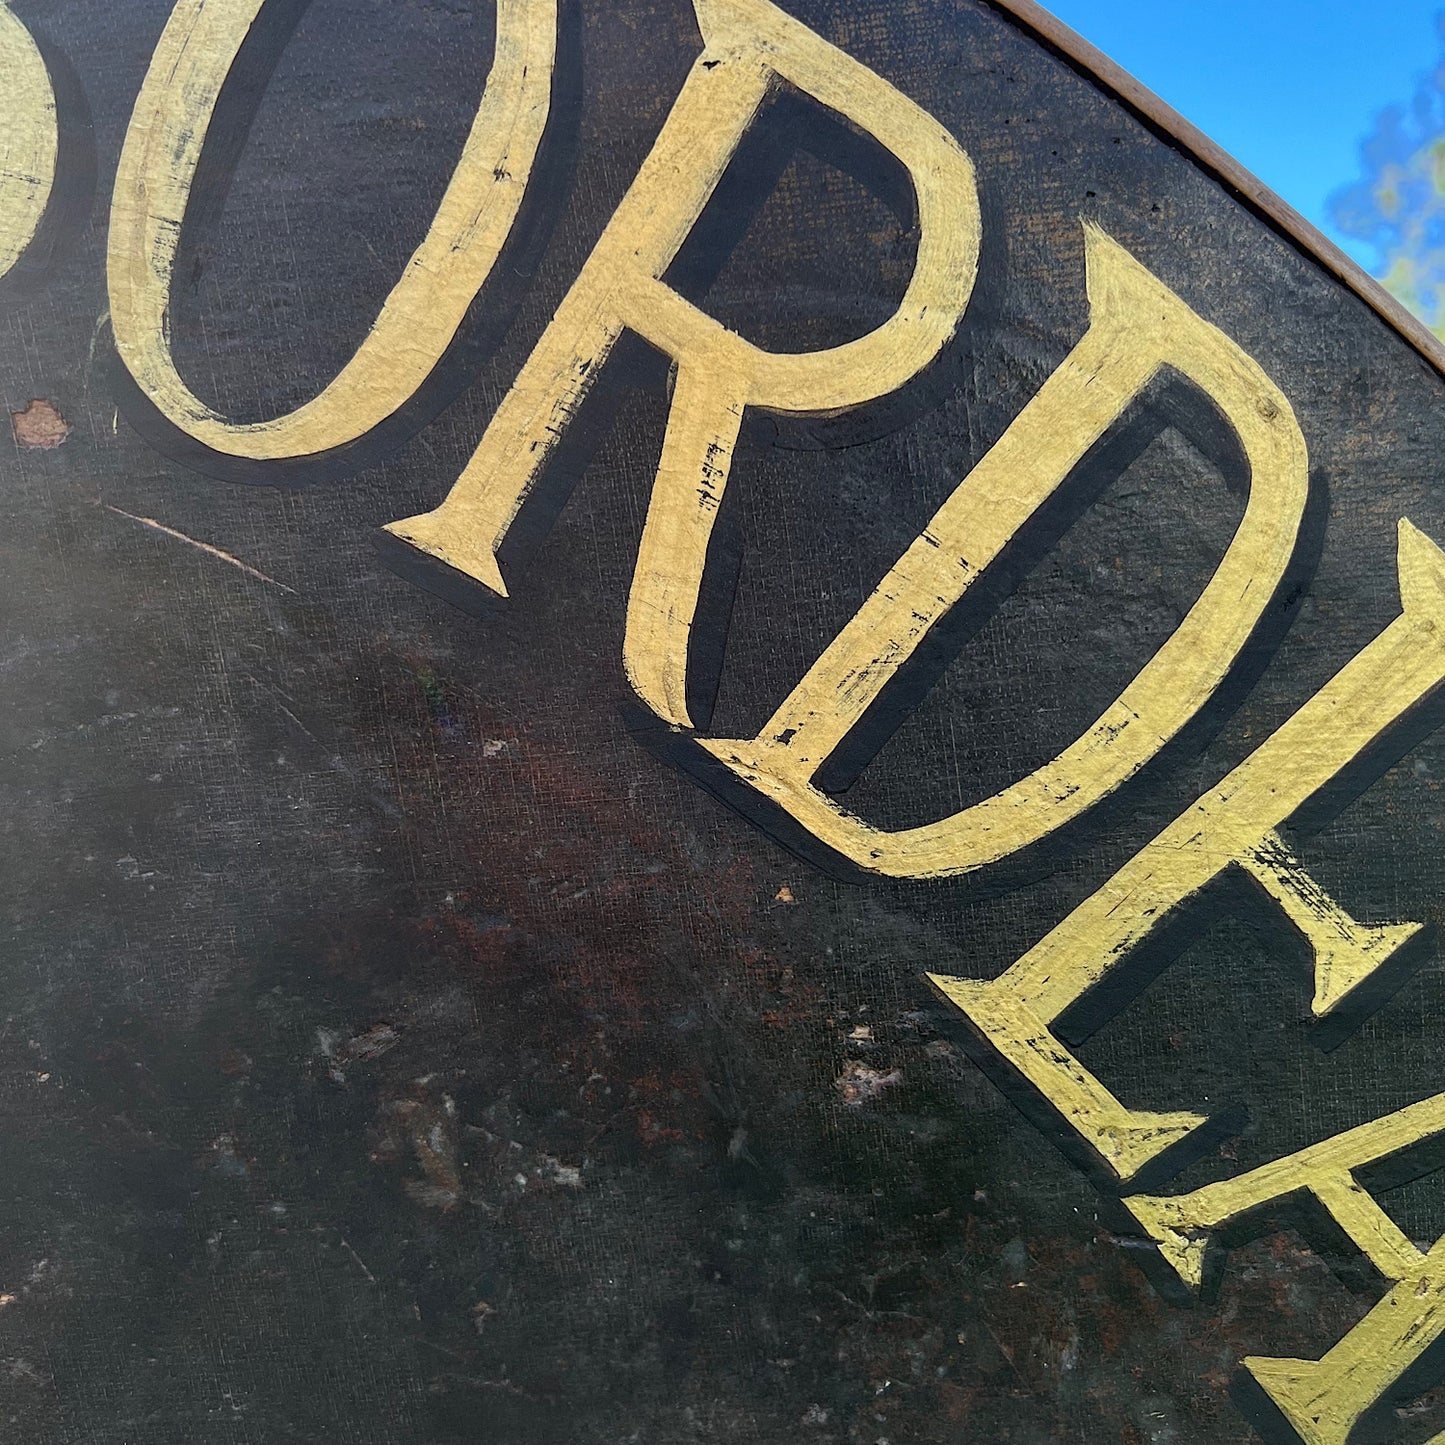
[{"xmin": 1043, "ymin": 0, "xmax": 1445, "ymax": 266}]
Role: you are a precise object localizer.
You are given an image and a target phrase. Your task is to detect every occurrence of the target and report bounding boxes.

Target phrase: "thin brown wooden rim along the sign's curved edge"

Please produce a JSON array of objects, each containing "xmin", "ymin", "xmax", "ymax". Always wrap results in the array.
[{"xmin": 987, "ymin": 0, "xmax": 1445, "ymax": 376}]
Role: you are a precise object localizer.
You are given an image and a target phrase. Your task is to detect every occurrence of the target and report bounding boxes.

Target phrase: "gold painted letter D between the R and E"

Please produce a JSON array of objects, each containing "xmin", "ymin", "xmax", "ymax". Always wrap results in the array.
[{"xmin": 701, "ymin": 227, "xmax": 1309, "ymax": 879}]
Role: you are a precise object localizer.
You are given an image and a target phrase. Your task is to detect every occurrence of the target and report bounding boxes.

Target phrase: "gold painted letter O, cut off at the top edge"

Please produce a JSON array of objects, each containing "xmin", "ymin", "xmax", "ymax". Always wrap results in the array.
[{"xmin": 108, "ymin": 0, "xmax": 556, "ymax": 461}]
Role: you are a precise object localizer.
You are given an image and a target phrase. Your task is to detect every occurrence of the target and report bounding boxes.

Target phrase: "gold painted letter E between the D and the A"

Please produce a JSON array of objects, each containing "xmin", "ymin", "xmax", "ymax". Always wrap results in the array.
[{"xmin": 931, "ymin": 520, "xmax": 1445, "ymax": 1179}]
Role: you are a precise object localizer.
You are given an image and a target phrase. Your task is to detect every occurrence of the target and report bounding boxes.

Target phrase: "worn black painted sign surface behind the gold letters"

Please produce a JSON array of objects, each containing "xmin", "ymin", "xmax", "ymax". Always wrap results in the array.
[{"xmin": 0, "ymin": 0, "xmax": 1445, "ymax": 1445}]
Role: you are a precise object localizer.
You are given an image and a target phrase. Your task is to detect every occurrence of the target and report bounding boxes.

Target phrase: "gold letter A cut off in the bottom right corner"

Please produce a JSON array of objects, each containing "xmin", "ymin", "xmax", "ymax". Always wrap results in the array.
[{"xmin": 1124, "ymin": 1094, "xmax": 1445, "ymax": 1445}]
